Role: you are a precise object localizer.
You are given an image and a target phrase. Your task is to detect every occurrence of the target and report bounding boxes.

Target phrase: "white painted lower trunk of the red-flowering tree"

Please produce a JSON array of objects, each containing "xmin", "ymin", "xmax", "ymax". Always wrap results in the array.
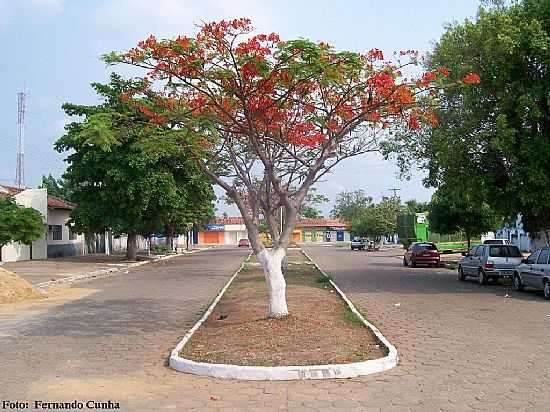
[{"xmin": 256, "ymin": 248, "xmax": 288, "ymax": 318}]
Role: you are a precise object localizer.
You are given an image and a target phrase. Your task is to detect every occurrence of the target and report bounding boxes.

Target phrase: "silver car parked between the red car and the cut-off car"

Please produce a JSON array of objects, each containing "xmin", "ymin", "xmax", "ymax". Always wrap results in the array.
[{"xmin": 458, "ymin": 245, "xmax": 523, "ymax": 285}]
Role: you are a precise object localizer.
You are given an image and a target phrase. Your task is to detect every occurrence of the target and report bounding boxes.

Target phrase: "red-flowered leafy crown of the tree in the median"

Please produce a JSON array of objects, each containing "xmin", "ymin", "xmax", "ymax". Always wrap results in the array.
[{"xmin": 113, "ymin": 19, "xmax": 480, "ymax": 148}]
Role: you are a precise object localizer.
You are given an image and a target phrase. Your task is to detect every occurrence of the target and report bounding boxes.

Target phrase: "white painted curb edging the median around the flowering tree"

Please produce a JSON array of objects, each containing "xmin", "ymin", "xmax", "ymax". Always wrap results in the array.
[{"xmin": 170, "ymin": 251, "xmax": 399, "ymax": 380}]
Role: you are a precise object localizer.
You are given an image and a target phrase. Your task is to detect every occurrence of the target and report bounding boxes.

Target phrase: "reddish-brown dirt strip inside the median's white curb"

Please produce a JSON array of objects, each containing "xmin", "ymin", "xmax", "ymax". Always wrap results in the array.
[{"xmin": 180, "ymin": 250, "xmax": 386, "ymax": 366}]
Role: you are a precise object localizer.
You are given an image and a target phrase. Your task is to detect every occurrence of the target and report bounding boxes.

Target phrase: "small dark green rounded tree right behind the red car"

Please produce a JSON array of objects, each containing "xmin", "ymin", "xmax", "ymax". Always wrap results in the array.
[{"xmin": 429, "ymin": 188, "xmax": 502, "ymax": 249}]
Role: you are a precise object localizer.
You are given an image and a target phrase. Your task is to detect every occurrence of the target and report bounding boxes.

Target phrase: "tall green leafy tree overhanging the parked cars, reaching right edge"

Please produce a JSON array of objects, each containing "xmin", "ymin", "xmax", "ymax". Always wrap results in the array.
[{"xmin": 390, "ymin": 0, "xmax": 550, "ymax": 232}]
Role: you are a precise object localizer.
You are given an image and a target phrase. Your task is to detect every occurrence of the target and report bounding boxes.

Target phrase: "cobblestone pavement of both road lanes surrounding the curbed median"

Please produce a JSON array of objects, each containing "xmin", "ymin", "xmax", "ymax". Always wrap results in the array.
[{"xmin": 0, "ymin": 247, "xmax": 550, "ymax": 411}]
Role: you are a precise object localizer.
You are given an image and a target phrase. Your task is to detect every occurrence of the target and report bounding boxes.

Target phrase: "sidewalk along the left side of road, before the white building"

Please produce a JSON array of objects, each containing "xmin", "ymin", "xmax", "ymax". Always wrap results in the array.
[{"xmin": 2, "ymin": 248, "xmax": 212, "ymax": 287}]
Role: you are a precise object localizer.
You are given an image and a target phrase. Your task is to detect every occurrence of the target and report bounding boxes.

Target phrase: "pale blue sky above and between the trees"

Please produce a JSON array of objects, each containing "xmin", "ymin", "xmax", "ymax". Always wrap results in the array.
[{"xmin": 0, "ymin": 0, "xmax": 479, "ymax": 213}]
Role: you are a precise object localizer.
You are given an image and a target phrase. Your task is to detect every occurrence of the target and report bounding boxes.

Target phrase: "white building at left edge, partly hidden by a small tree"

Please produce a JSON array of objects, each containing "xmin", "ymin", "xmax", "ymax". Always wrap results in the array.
[{"xmin": 0, "ymin": 186, "xmax": 84, "ymax": 262}]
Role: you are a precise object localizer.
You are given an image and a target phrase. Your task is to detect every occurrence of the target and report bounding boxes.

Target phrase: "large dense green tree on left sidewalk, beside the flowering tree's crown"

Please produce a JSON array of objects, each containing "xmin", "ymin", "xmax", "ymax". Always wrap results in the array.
[{"xmin": 55, "ymin": 74, "xmax": 214, "ymax": 260}]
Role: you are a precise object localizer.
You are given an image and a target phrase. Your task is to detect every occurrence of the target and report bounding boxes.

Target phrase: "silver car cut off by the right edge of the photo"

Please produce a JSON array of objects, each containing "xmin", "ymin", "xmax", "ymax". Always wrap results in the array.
[{"xmin": 514, "ymin": 247, "xmax": 550, "ymax": 299}]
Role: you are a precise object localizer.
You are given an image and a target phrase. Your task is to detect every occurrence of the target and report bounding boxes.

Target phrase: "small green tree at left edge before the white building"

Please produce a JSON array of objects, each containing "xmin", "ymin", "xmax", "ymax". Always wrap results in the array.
[{"xmin": 0, "ymin": 196, "xmax": 44, "ymax": 262}]
